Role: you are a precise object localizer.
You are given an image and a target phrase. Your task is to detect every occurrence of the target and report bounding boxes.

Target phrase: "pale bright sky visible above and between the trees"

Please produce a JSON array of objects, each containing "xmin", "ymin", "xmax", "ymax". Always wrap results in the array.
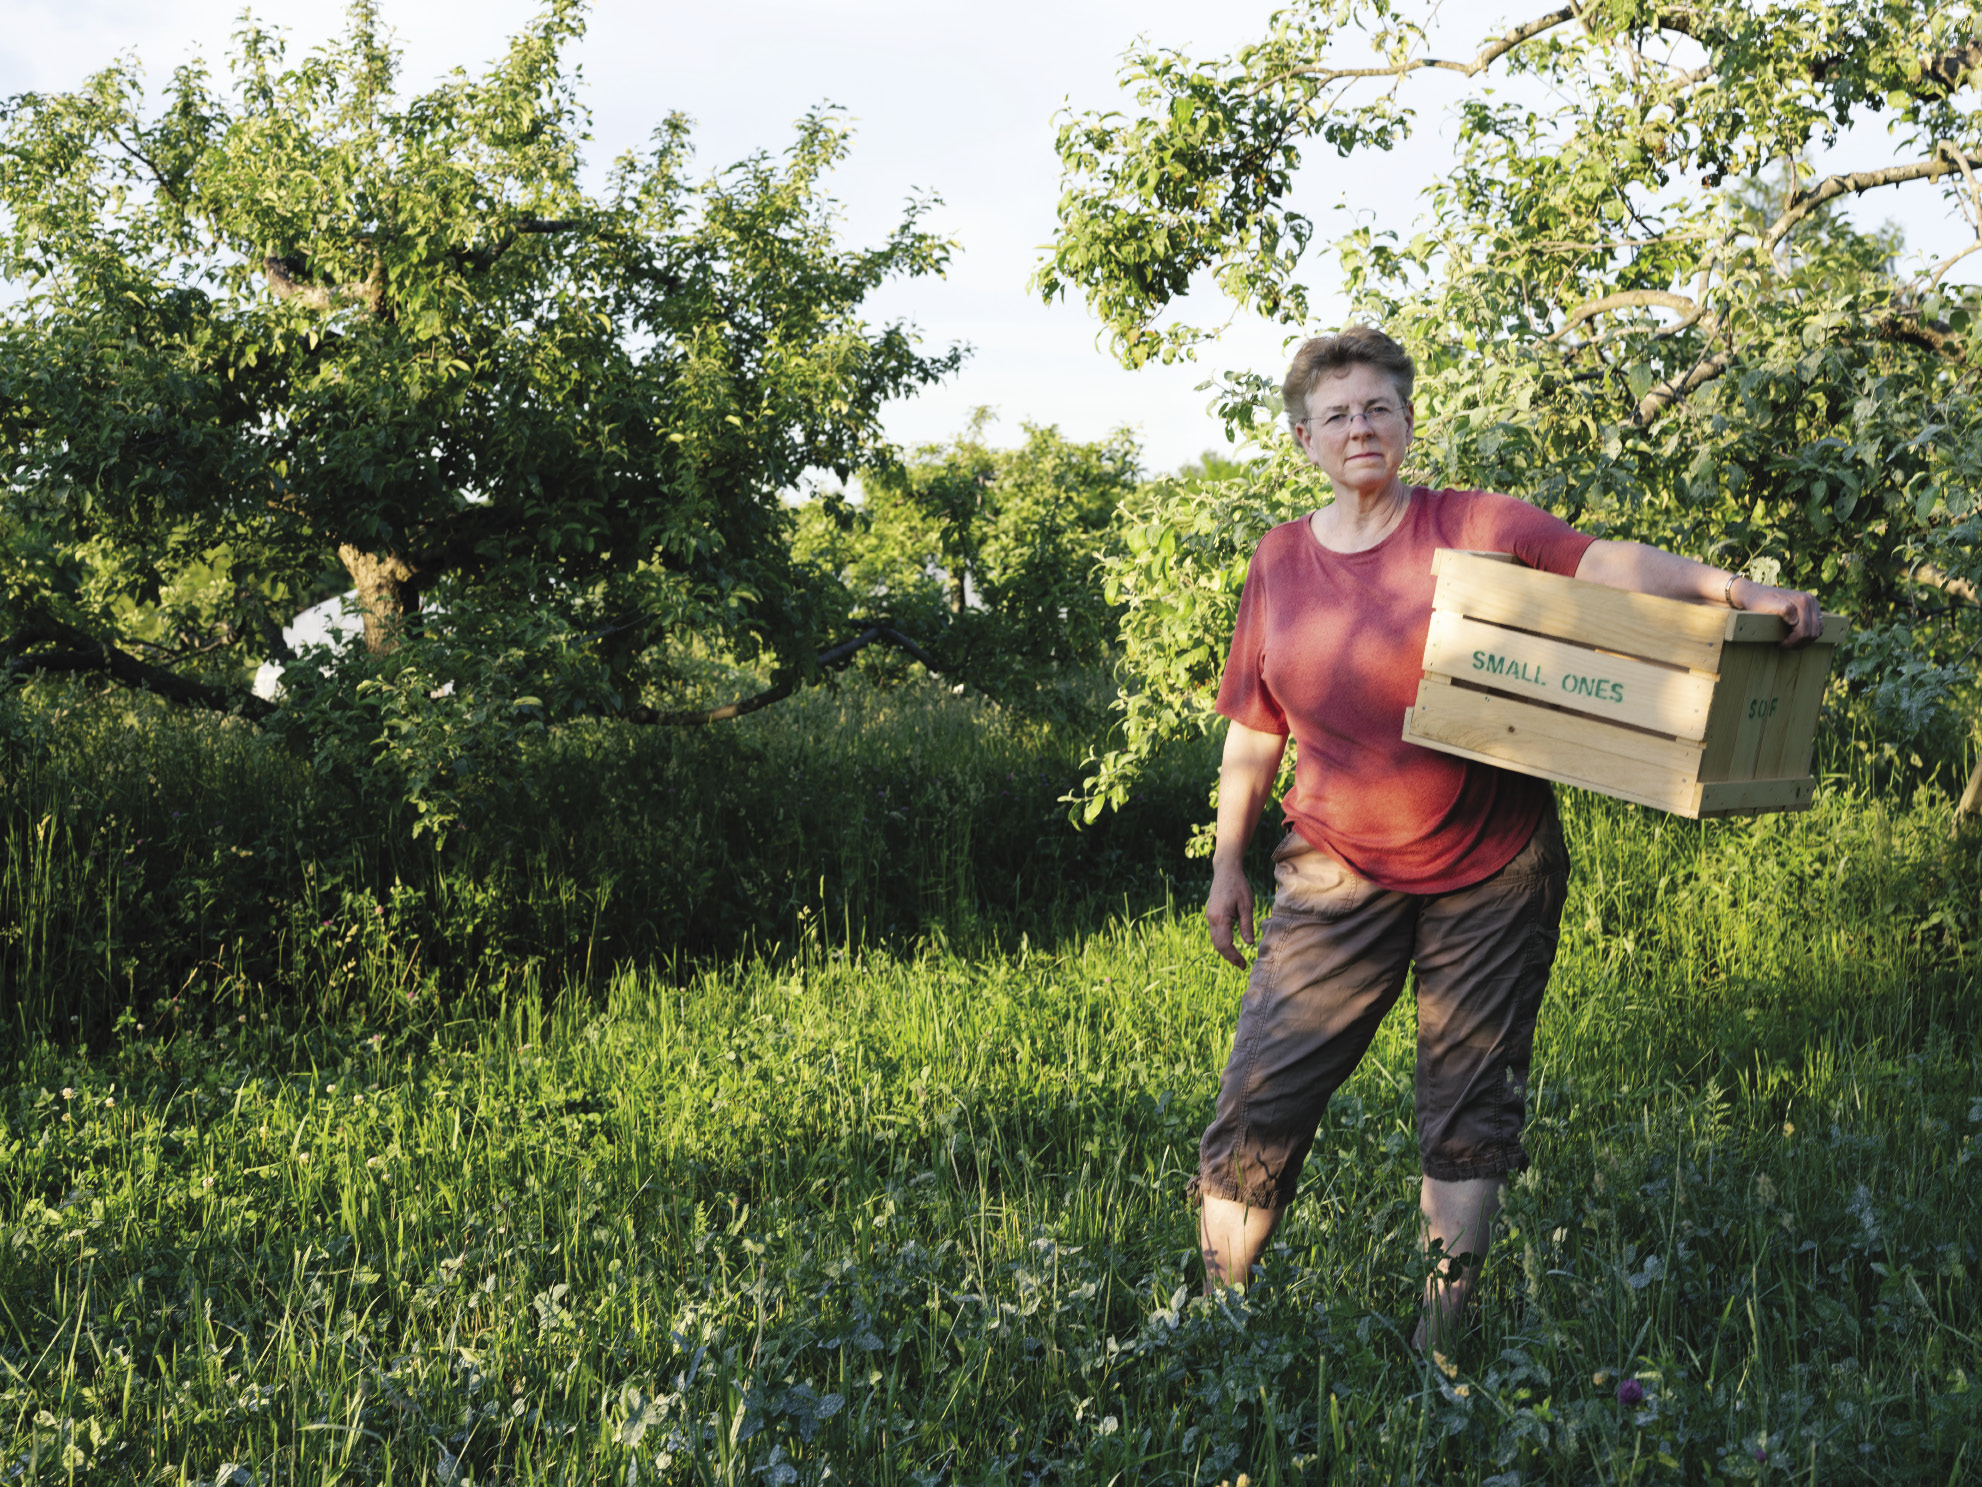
[{"xmin": 0, "ymin": 0, "xmax": 1982, "ymax": 485}]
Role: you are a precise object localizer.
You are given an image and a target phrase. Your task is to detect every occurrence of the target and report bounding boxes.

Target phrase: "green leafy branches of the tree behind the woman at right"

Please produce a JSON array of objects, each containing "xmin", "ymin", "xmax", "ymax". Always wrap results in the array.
[{"xmin": 1039, "ymin": 0, "xmax": 1982, "ymax": 816}]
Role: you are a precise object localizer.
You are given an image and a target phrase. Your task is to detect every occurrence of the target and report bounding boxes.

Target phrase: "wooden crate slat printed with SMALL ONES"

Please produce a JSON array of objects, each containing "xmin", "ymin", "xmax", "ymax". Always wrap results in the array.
[{"xmin": 1425, "ymin": 609, "xmax": 1714, "ymax": 740}]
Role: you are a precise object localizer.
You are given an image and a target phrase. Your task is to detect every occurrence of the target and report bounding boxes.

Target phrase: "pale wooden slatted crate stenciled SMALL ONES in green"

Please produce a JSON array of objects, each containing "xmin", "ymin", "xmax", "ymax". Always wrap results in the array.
[{"xmin": 1403, "ymin": 549, "xmax": 1849, "ymax": 817}]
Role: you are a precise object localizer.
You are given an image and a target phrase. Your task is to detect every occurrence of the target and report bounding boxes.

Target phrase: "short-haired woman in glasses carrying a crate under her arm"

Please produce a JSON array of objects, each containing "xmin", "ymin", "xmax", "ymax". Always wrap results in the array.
[{"xmin": 1193, "ymin": 327, "xmax": 1821, "ymax": 1348}]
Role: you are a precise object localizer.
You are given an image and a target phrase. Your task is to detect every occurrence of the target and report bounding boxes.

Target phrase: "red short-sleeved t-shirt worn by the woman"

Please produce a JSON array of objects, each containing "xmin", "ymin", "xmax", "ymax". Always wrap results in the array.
[{"xmin": 1219, "ymin": 486, "xmax": 1596, "ymax": 894}]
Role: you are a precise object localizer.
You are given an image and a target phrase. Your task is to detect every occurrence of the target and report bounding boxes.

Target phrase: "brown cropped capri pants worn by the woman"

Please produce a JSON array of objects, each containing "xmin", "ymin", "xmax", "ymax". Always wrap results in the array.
[{"xmin": 1191, "ymin": 803, "xmax": 1570, "ymax": 1207}]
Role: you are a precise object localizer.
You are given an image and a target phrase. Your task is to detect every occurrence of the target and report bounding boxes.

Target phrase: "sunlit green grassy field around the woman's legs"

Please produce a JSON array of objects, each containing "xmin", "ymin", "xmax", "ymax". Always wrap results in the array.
[{"xmin": 0, "ymin": 757, "xmax": 1982, "ymax": 1487}]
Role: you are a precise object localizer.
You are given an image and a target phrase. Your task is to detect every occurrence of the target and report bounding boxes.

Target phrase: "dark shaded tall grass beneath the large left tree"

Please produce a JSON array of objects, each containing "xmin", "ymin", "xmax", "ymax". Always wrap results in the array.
[{"xmin": 0, "ymin": 684, "xmax": 1209, "ymax": 1037}]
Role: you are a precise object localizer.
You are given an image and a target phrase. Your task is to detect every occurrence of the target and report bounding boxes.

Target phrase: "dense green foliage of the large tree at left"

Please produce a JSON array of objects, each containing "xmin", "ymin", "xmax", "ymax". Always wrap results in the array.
[{"xmin": 0, "ymin": 0, "xmax": 959, "ymax": 730}]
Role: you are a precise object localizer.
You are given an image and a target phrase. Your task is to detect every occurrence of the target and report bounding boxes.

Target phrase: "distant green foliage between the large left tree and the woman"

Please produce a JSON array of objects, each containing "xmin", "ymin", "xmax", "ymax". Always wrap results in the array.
[{"xmin": 795, "ymin": 408, "xmax": 1142, "ymax": 714}]
